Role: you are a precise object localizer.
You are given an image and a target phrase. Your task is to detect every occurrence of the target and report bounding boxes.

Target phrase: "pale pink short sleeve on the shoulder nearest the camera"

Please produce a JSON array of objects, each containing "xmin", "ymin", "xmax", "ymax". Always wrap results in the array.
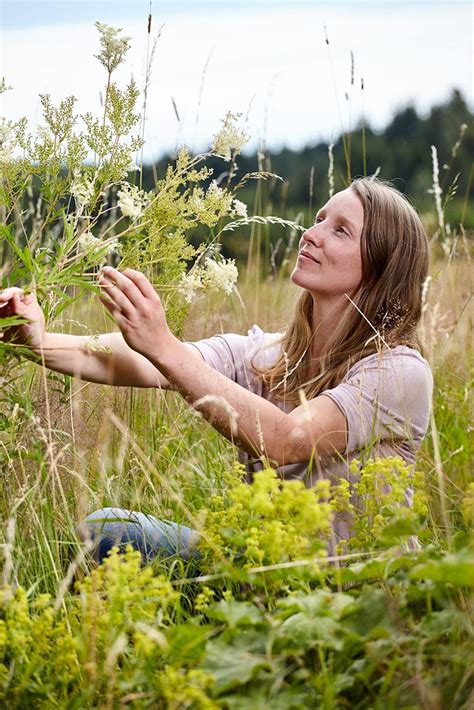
[{"xmin": 322, "ymin": 346, "xmax": 433, "ymax": 454}]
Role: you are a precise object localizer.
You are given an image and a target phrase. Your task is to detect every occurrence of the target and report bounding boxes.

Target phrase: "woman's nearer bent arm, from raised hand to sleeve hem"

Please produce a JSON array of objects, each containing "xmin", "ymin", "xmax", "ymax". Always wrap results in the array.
[{"xmin": 101, "ymin": 268, "xmax": 347, "ymax": 466}]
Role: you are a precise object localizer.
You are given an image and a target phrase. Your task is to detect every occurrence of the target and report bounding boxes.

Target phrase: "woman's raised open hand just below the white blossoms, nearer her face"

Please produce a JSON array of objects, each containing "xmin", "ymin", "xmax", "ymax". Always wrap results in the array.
[{"xmin": 99, "ymin": 266, "xmax": 176, "ymax": 358}]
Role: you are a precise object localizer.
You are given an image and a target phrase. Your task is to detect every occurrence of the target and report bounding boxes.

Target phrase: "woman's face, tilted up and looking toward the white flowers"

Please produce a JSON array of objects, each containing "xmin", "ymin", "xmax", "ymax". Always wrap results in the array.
[{"xmin": 291, "ymin": 188, "xmax": 364, "ymax": 300}]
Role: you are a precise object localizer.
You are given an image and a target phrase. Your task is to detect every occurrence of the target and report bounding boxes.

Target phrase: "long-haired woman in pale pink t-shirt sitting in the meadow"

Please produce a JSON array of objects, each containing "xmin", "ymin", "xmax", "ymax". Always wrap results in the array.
[{"xmin": 0, "ymin": 178, "xmax": 432, "ymax": 560}]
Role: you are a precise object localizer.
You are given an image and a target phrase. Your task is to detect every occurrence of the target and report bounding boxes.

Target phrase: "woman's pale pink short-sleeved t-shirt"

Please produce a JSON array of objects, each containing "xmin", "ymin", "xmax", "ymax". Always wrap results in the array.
[{"xmin": 193, "ymin": 325, "xmax": 433, "ymax": 538}]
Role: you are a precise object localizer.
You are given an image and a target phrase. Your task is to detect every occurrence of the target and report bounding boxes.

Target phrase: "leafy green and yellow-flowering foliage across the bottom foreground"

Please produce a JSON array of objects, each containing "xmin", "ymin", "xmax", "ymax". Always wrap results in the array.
[{"xmin": 0, "ymin": 524, "xmax": 474, "ymax": 710}]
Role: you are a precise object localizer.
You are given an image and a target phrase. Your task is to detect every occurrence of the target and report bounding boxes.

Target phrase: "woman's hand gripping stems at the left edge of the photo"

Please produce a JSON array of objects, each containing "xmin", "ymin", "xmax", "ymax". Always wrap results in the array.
[{"xmin": 0, "ymin": 286, "xmax": 46, "ymax": 351}]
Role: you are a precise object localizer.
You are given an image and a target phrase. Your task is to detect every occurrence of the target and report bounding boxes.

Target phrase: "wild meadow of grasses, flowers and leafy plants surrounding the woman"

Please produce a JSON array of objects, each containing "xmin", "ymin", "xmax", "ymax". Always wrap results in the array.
[{"xmin": 0, "ymin": 20, "xmax": 474, "ymax": 710}]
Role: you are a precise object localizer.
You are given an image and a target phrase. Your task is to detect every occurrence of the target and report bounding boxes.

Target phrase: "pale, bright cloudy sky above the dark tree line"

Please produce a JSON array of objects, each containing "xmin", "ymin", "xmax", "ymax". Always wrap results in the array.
[{"xmin": 0, "ymin": 0, "xmax": 473, "ymax": 160}]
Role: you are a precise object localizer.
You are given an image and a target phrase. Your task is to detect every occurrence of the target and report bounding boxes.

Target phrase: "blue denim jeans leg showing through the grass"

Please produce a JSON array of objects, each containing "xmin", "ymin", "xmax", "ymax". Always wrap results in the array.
[{"xmin": 77, "ymin": 508, "xmax": 199, "ymax": 563}]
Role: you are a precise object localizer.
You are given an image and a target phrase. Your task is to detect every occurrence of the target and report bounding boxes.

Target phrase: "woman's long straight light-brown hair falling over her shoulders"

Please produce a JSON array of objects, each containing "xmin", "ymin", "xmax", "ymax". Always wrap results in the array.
[{"xmin": 255, "ymin": 178, "xmax": 429, "ymax": 404}]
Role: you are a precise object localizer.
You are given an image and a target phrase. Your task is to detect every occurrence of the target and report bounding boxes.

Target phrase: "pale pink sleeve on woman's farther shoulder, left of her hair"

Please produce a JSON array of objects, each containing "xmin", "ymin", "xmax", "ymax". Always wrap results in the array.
[{"xmin": 187, "ymin": 325, "xmax": 282, "ymax": 394}]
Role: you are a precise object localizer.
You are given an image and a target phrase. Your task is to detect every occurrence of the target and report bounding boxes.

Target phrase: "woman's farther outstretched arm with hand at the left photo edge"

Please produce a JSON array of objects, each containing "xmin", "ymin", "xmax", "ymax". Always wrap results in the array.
[{"xmin": 0, "ymin": 288, "xmax": 202, "ymax": 389}]
